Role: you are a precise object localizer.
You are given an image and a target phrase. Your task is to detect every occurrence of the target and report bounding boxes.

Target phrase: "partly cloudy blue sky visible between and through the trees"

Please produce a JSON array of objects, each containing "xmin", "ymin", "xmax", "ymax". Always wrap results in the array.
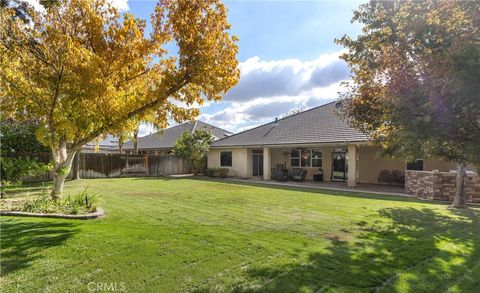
[{"xmin": 120, "ymin": 0, "xmax": 361, "ymax": 134}]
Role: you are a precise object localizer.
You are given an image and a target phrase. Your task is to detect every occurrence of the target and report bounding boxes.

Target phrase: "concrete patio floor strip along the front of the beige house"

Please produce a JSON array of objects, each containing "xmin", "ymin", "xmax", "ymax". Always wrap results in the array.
[{"xmin": 225, "ymin": 178, "xmax": 408, "ymax": 197}]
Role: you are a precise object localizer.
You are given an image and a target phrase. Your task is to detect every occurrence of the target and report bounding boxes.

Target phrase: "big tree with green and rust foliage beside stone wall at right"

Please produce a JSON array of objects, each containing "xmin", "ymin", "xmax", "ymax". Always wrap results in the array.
[{"xmin": 337, "ymin": 0, "xmax": 480, "ymax": 207}]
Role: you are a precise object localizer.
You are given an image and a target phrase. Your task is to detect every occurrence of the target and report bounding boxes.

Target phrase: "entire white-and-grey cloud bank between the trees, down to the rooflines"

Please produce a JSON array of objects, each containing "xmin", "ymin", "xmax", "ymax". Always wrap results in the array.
[{"xmin": 200, "ymin": 51, "xmax": 350, "ymax": 132}]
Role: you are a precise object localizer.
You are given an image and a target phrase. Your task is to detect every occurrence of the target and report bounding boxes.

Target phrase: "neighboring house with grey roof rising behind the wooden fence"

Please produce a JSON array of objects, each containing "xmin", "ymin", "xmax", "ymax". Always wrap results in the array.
[{"xmin": 123, "ymin": 120, "xmax": 233, "ymax": 155}]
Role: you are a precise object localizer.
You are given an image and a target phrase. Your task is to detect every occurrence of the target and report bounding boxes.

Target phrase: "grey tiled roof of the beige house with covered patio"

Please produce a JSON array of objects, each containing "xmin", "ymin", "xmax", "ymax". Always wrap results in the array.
[{"xmin": 212, "ymin": 102, "xmax": 368, "ymax": 148}]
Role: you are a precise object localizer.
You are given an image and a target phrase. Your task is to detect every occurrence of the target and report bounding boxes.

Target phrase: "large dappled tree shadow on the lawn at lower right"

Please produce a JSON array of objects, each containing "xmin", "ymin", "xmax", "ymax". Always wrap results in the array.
[{"xmin": 230, "ymin": 208, "xmax": 480, "ymax": 292}]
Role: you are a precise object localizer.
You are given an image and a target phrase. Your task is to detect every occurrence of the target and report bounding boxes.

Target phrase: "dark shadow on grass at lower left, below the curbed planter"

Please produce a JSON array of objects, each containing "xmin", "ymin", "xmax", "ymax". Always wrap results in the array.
[{"xmin": 0, "ymin": 217, "xmax": 78, "ymax": 277}]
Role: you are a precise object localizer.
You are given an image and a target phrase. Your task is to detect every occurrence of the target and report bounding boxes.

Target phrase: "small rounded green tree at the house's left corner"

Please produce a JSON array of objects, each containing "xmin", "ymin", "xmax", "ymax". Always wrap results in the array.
[{"xmin": 173, "ymin": 128, "xmax": 213, "ymax": 174}]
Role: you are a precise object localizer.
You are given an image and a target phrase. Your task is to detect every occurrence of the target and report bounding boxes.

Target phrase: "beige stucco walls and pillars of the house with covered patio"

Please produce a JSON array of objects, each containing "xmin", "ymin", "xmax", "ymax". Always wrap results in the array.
[{"xmin": 208, "ymin": 145, "xmax": 455, "ymax": 185}]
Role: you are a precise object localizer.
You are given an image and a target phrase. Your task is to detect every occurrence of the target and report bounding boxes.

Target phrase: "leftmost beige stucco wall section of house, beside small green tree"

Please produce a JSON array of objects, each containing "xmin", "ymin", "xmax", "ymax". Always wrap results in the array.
[{"xmin": 207, "ymin": 148, "xmax": 252, "ymax": 178}]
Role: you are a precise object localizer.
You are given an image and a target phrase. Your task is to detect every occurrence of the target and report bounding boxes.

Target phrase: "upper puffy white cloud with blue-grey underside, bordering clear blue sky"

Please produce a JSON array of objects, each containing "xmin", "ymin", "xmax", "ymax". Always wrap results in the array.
[{"xmin": 224, "ymin": 51, "xmax": 350, "ymax": 102}]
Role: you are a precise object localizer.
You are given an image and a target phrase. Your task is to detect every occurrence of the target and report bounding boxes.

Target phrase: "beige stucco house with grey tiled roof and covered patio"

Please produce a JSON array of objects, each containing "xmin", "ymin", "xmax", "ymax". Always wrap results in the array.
[{"xmin": 208, "ymin": 102, "xmax": 455, "ymax": 186}]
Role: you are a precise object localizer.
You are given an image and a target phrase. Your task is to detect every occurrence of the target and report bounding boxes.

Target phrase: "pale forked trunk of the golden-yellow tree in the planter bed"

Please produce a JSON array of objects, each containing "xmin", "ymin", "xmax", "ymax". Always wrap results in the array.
[{"xmin": 50, "ymin": 143, "xmax": 77, "ymax": 200}]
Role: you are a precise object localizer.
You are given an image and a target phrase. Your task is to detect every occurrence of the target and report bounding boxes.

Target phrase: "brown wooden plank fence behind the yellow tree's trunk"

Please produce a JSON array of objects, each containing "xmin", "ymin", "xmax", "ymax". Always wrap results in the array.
[{"xmin": 4, "ymin": 153, "xmax": 191, "ymax": 181}]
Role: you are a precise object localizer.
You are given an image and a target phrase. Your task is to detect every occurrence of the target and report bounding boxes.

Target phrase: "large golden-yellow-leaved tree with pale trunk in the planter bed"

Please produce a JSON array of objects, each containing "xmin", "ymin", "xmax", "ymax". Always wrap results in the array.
[{"xmin": 0, "ymin": 0, "xmax": 239, "ymax": 199}]
